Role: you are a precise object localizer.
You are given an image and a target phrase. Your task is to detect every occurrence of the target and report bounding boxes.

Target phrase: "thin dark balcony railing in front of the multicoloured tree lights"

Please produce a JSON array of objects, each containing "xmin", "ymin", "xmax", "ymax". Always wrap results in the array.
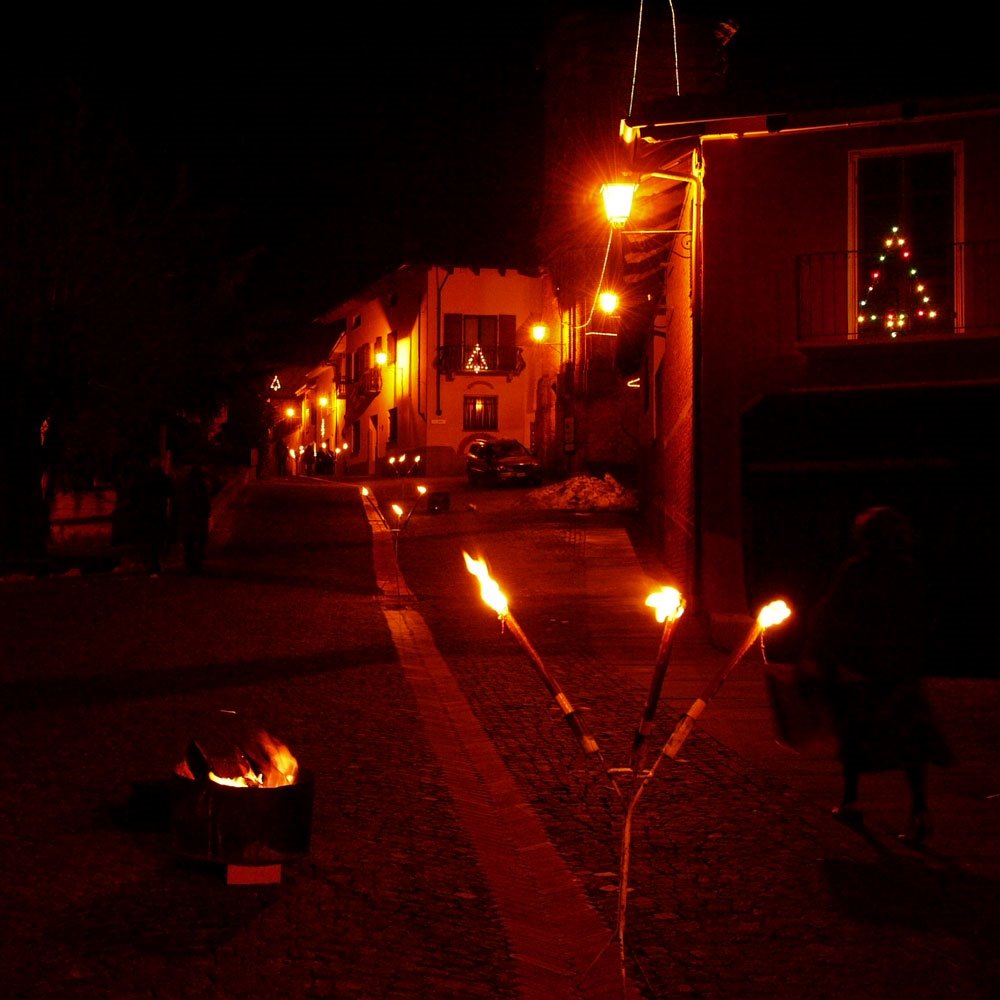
[{"xmin": 796, "ymin": 240, "xmax": 1000, "ymax": 344}]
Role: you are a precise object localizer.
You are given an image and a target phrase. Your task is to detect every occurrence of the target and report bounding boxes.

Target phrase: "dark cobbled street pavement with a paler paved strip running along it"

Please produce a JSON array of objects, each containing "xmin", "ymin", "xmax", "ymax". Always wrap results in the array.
[{"xmin": 0, "ymin": 480, "xmax": 1000, "ymax": 998}]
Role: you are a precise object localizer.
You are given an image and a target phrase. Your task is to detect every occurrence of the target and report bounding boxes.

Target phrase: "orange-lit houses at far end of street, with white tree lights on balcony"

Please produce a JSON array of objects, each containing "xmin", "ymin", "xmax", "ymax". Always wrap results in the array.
[{"xmin": 287, "ymin": 265, "xmax": 572, "ymax": 476}]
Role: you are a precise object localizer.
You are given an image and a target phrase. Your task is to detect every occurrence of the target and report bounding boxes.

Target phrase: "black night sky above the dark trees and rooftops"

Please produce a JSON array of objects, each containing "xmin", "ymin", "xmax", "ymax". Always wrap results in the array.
[{"xmin": 0, "ymin": 0, "xmax": 995, "ymax": 332}]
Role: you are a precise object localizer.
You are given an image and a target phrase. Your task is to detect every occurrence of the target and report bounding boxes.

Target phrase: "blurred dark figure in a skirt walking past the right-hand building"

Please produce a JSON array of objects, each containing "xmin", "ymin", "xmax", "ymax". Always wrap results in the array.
[{"xmin": 808, "ymin": 507, "xmax": 952, "ymax": 845}]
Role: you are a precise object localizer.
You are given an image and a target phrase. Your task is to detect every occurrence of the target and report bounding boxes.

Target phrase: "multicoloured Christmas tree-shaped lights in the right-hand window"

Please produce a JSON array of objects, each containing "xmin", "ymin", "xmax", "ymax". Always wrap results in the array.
[{"xmin": 858, "ymin": 226, "xmax": 938, "ymax": 337}]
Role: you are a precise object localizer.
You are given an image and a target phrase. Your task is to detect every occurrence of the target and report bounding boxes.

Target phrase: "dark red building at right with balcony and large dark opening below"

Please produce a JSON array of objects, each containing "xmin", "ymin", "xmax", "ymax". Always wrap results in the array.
[{"xmin": 621, "ymin": 90, "xmax": 1000, "ymax": 649}]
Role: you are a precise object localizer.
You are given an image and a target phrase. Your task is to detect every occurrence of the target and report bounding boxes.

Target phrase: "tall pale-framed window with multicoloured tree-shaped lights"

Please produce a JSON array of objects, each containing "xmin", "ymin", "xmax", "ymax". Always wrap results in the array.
[{"xmin": 852, "ymin": 148, "xmax": 957, "ymax": 338}]
